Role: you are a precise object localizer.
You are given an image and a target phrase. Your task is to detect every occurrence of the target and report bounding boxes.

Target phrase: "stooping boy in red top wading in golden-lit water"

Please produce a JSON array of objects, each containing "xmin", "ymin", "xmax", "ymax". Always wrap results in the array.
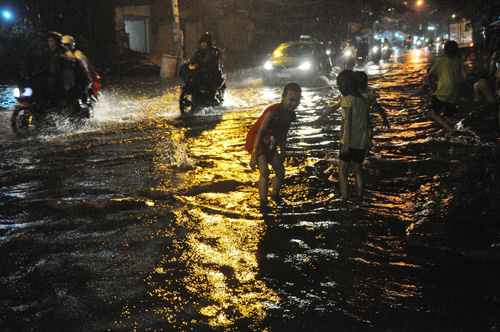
[{"xmin": 245, "ymin": 83, "xmax": 302, "ymax": 205}]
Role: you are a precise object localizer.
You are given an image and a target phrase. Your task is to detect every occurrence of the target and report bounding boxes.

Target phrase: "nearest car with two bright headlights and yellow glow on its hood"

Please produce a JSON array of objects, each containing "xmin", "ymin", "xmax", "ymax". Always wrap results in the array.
[{"xmin": 262, "ymin": 37, "xmax": 332, "ymax": 85}]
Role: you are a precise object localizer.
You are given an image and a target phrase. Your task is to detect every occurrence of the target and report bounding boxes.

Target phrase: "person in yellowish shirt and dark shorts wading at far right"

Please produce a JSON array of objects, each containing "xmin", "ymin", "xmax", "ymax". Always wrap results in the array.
[{"xmin": 425, "ymin": 40, "xmax": 466, "ymax": 133}]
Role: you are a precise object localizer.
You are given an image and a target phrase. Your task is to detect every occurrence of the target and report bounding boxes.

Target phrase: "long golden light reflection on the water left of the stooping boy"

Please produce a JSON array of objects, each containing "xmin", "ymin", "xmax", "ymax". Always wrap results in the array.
[{"xmin": 147, "ymin": 109, "xmax": 280, "ymax": 331}]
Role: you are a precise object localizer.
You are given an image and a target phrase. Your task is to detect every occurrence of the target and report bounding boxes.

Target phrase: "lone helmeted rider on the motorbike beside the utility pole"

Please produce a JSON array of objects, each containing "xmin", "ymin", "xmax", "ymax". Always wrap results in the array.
[{"xmin": 190, "ymin": 32, "xmax": 223, "ymax": 94}]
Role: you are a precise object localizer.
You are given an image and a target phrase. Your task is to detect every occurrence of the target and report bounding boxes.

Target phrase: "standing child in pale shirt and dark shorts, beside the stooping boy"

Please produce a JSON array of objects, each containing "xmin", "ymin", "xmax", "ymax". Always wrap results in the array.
[{"xmin": 337, "ymin": 70, "xmax": 371, "ymax": 202}]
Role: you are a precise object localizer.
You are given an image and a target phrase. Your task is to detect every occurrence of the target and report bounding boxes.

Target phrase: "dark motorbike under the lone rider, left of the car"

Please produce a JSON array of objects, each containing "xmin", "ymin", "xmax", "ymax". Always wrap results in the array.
[{"xmin": 179, "ymin": 63, "xmax": 226, "ymax": 113}]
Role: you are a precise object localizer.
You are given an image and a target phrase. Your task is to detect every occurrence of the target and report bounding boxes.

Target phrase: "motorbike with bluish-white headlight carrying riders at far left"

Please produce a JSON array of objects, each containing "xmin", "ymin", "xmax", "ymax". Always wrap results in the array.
[{"xmin": 11, "ymin": 73, "xmax": 100, "ymax": 133}]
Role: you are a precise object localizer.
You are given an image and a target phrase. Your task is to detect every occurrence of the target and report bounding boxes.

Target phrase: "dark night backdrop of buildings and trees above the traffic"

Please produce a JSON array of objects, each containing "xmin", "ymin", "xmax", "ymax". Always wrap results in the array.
[{"xmin": 0, "ymin": 0, "xmax": 500, "ymax": 77}]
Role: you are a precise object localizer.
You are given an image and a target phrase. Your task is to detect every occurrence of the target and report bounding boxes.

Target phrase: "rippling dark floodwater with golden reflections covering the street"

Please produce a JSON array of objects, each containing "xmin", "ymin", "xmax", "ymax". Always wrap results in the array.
[{"xmin": 0, "ymin": 51, "xmax": 500, "ymax": 332}]
